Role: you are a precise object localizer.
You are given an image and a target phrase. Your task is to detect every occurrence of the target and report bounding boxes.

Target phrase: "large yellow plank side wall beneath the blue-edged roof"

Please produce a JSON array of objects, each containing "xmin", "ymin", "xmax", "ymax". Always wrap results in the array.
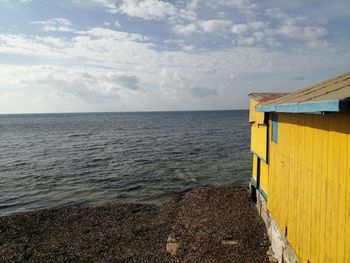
[{"xmin": 267, "ymin": 113, "xmax": 350, "ymax": 263}]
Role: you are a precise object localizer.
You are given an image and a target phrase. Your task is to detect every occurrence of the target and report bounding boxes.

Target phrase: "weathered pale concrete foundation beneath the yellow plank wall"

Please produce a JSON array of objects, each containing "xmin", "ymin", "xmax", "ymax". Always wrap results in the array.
[{"xmin": 250, "ymin": 185, "xmax": 300, "ymax": 263}]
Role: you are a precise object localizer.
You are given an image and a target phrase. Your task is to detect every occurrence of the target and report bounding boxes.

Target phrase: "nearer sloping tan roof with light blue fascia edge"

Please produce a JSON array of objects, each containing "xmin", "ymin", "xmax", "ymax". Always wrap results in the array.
[{"xmin": 256, "ymin": 72, "xmax": 350, "ymax": 113}]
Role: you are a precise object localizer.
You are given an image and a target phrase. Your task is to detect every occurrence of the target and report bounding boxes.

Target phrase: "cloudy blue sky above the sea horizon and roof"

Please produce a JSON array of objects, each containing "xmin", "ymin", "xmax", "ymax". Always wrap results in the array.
[{"xmin": 0, "ymin": 0, "xmax": 350, "ymax": 114}]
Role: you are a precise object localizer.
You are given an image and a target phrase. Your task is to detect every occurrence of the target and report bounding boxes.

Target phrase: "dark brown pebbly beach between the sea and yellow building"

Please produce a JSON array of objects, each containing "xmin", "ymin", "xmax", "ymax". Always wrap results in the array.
[{"xmin": 0, "ymin": 187, "xmax": 270, "ymax": 263}]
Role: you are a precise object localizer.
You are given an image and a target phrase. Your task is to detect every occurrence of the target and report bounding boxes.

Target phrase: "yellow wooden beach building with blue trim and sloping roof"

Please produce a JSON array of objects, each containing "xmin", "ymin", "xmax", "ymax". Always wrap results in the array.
[{"xmin": 249, "ymin": 72, "xmax": 350, "ymax": 263}]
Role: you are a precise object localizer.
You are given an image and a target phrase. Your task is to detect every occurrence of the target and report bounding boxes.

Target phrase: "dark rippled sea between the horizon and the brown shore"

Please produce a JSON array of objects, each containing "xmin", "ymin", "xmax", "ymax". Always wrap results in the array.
[{"xmin": 0, "ymin": 111, "xmax": 251, "ymax": 215}]
